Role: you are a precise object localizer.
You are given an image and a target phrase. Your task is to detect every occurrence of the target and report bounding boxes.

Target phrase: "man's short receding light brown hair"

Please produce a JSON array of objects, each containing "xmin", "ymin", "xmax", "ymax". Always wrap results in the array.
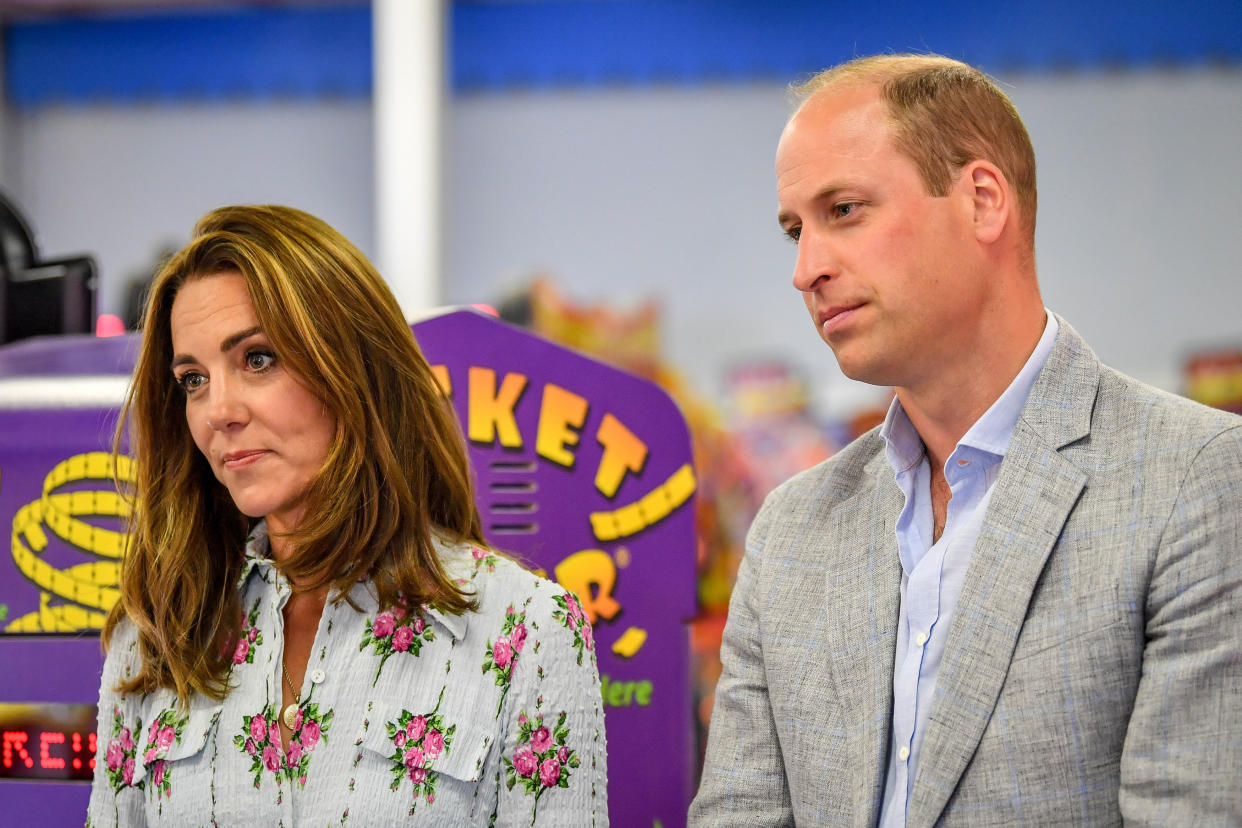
[{"xmin": 792, "ymin": 55, "xmax": 1037, "ymax": 247}]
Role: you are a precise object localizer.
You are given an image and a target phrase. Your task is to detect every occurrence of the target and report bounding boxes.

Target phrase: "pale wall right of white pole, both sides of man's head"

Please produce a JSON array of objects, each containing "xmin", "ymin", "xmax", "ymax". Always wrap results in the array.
[{"xmin": 447, "ymin": 71, "xmax": 1242, "ymax": 412}]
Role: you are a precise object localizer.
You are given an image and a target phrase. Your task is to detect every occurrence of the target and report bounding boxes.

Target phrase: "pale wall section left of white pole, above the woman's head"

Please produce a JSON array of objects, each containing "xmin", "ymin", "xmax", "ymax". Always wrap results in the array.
[{"xmin": 4, "ymin": 102, "xmax": 375, "ymax": 313}]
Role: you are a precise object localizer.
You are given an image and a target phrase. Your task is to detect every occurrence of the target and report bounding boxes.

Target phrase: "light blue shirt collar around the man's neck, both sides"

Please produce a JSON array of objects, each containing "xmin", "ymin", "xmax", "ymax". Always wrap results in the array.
[{"xmin": 879, "ymin": 309, "xmax": 1059, "ymax": 474}]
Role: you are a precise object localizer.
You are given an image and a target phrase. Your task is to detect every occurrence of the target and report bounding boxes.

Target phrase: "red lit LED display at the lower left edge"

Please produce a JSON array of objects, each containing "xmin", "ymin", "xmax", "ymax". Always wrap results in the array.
[{"xmin": 0, "ymin": 703, "xmax": 98, "ymax": 781}]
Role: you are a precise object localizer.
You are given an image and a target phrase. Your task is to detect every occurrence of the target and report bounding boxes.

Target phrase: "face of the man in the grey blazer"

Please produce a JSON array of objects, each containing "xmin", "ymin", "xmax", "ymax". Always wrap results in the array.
[{"xmin": 776, "ymin": 87, "xmax": 986, "ymax": 387}]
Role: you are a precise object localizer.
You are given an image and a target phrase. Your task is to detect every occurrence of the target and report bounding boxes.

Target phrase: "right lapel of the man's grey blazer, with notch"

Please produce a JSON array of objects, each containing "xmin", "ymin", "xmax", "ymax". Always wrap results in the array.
[{"xmin": 907, "ymin": 317, "xmax": 1099, "ymax": 826}]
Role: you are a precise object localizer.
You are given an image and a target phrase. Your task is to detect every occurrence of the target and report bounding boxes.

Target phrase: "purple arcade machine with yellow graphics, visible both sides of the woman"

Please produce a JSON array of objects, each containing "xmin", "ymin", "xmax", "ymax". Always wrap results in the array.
[{"xmin": 0, "ymin": 310, "xmax": 696, "ymax": 828}]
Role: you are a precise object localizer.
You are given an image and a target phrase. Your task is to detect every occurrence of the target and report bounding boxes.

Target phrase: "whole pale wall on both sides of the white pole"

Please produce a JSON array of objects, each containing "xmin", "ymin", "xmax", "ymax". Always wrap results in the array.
[{"xmin": 9, "ymin": 70, "xmax": 1242, "ymax": 422}]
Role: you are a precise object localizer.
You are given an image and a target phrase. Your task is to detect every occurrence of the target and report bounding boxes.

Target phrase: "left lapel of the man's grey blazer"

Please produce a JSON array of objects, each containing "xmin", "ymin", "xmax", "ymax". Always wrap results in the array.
[{"xmin": 823, "ymin": 452, "xmax": 902, "ymax": 826}]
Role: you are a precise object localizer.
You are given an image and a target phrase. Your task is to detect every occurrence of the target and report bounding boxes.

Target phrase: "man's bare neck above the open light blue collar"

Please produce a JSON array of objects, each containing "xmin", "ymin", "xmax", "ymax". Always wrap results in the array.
[{"xmin": 897, "ymin": 305, "xmax": 1047, "ymax": 469}]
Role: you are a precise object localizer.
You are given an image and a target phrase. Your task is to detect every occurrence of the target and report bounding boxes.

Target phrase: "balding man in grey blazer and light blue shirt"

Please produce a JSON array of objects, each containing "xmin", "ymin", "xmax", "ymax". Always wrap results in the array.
[{"xmin": 691, "ymin": 56, "xmax": 1242, "ymax": 826}]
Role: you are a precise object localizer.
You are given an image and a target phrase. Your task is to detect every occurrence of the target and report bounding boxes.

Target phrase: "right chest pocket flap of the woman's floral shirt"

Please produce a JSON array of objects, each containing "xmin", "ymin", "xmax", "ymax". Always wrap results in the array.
[{"xmin": 363, "ymin": 701, "xmax": 492, "ymax": 782}]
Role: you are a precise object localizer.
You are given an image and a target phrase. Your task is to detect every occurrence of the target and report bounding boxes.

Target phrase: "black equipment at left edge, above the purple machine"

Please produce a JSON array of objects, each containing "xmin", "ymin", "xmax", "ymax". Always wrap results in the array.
[{"xmin": 0, "ymin": 195, "xmax": 96, "ymax": 344}]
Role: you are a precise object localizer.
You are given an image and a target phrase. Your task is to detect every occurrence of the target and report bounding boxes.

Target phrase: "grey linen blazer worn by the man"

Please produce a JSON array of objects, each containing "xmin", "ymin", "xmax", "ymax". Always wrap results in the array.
[{"xmin": 689, "ymin": 317, "xmax": 1242, "ymax": 826}]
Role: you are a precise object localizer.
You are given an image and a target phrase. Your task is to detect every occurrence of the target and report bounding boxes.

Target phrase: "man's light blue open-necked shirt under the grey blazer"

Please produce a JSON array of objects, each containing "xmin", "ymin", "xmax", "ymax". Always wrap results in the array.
[{"xmin": 879, "ymin": 313, "xmax": 1057, "ymax": 828}]
